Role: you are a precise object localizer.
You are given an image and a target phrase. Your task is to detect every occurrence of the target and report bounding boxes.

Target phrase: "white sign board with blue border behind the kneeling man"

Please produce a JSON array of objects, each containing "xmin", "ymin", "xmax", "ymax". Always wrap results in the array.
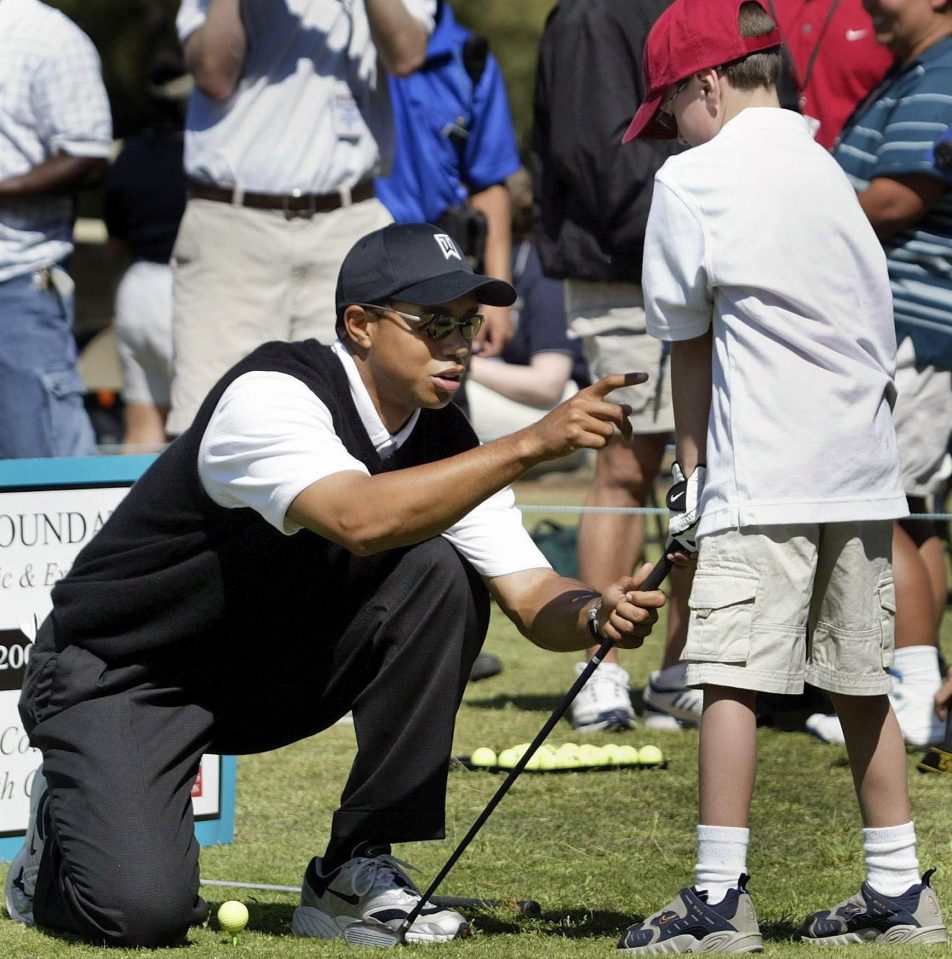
[{"xmin": 0, "ymin": 456, "xmax": 236, "ymax": 860}]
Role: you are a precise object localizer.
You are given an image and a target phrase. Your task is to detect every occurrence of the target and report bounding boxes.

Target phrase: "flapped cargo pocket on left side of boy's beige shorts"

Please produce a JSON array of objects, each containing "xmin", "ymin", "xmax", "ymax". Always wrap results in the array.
[{"xmin": 683, "ymin": 573, "xmax": 758, "ymax": 663}]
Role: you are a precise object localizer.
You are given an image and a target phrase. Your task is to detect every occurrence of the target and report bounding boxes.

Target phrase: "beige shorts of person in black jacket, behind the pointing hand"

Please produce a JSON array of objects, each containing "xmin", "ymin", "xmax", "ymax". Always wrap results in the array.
[{"xmin": 565, "ymin": 280, "xmax": 674, "ymax": 433}]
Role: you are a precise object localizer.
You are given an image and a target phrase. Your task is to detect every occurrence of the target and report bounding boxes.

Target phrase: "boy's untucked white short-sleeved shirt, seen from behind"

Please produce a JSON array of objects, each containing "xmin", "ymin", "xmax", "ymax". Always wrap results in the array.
[{"xmin": 642, "ymin": 108, "xmax": 908, "ymax": 535}]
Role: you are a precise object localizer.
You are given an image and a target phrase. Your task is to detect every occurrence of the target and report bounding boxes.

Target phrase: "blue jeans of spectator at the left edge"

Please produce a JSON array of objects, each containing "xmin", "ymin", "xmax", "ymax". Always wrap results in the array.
[{"xmin": 0, "ymin": 266, "xmax": 96, "ymax": 459}]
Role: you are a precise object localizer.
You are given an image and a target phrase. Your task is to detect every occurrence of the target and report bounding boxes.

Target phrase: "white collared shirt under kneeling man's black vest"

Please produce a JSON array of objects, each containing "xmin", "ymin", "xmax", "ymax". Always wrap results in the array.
[{"xmin": 198, "ymin": 340, "xmax": 550, "ymax": 578}]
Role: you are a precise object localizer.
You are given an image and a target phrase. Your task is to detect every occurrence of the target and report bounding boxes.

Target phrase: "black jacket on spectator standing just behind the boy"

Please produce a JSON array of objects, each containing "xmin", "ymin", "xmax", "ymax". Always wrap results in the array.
[{"xmin": 531, "ymin": 0, "xmax": 680, "ymax": 283}]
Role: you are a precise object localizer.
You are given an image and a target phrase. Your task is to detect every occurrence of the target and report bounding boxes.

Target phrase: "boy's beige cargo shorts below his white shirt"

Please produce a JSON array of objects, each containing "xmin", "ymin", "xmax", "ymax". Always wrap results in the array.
[{"xmin": 682, "ymin": 520, "xmax": 896, "ymax": 696}]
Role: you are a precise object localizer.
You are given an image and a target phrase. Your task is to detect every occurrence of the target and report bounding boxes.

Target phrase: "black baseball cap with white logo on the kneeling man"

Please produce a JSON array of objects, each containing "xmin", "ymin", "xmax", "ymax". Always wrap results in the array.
[{"xmin": 336, "ymin": 223, "xmax": 516, "ymax": 319}]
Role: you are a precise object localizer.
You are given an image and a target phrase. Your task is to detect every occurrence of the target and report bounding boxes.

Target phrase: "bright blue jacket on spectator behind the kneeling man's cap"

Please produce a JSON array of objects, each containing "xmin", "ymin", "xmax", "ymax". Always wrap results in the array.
[{"xmin": 376, "ymin": 3, "xmax": 519, "ymax": 223}]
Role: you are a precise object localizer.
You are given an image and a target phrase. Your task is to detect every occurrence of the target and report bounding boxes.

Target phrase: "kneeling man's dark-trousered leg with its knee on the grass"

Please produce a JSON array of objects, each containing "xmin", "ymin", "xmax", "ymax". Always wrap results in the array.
[{"xmin": 11, "ymin": 620, "xmax": 212, "ymax": 947}]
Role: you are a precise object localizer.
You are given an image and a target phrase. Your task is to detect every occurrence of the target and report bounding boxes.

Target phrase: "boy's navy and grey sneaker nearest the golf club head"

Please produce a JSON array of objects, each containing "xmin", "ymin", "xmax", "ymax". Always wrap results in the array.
[{"xmin": 618, "ymin": 875, "xmax": 764, "ymax": 955}]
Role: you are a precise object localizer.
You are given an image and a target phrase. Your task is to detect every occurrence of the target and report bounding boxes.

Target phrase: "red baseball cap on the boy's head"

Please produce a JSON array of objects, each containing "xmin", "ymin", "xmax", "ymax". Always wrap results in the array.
[{"xmin": 621, "ymin": 0, "xmax": 781, "ymax": 143}]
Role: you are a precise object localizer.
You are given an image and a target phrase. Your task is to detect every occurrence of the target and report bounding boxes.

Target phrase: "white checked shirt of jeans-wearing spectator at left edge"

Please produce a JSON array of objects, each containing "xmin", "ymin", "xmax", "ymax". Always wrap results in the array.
[{"xmin": 0, "ymin": 0, "xmax": 112, "ymax": 282}]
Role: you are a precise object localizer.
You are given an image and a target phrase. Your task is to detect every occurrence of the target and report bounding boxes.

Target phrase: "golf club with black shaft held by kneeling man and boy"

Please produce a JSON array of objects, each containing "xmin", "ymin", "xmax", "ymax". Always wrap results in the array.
[{"xmin": 344, "ymin": 545, "xmax": 673, "ymax": 949}]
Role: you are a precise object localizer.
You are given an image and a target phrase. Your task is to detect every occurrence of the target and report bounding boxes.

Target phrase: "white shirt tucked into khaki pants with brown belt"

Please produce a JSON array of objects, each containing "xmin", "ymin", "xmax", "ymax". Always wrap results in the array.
[{"xmin": 176, "ymin": 0, "xmax": 436, "ymax": 194}]
